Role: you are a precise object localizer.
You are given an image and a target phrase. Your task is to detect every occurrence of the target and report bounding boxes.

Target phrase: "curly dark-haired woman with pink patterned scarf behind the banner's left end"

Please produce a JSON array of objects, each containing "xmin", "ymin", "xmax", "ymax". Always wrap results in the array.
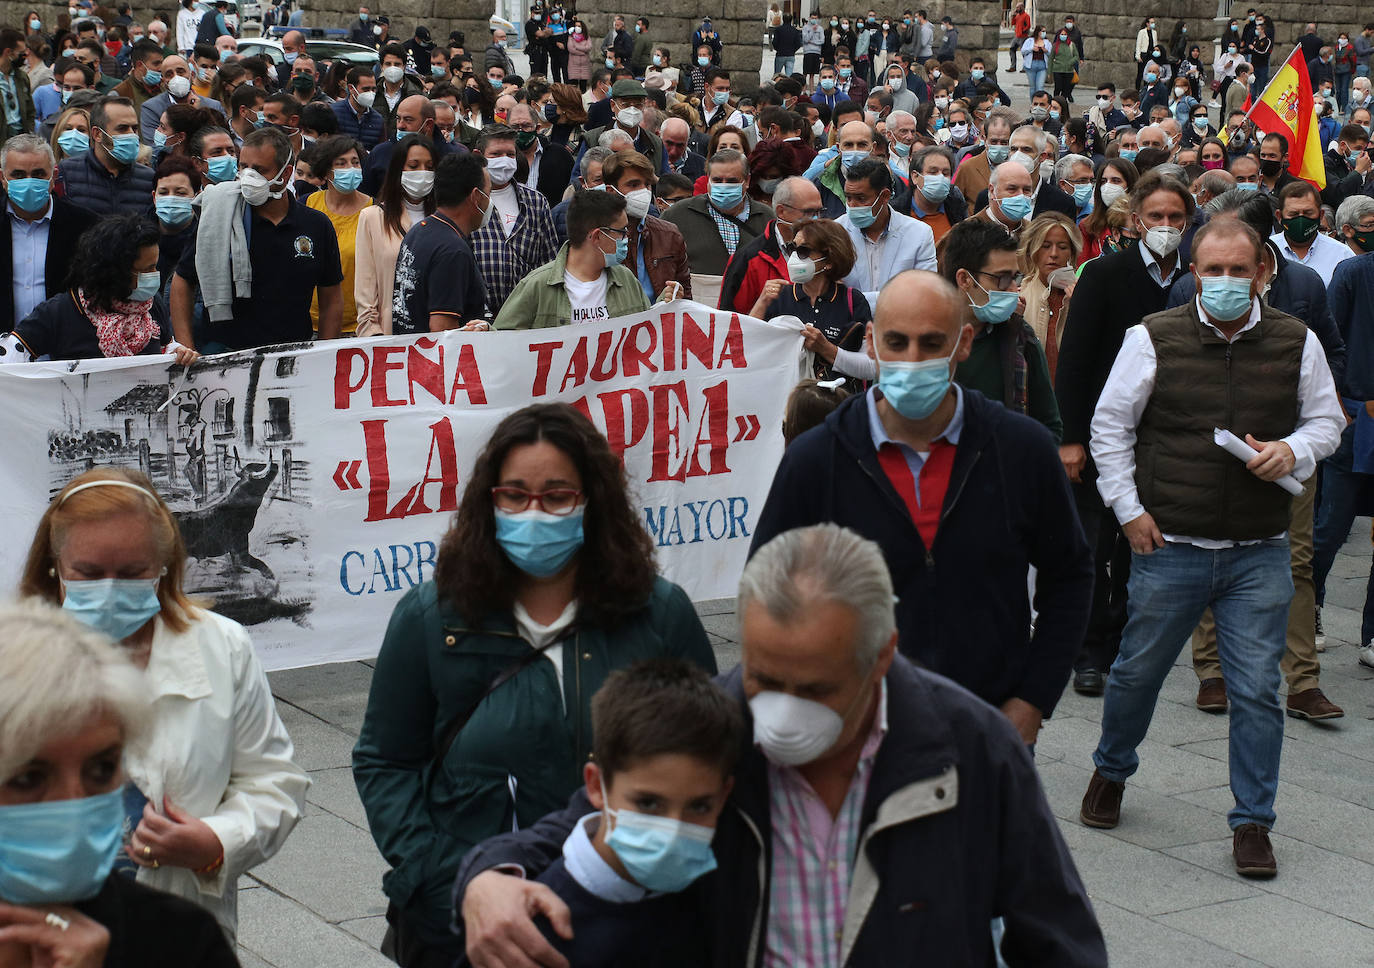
[{"xmin": 0, "ymin": 214, "xmax": 199, "ymax": 364}]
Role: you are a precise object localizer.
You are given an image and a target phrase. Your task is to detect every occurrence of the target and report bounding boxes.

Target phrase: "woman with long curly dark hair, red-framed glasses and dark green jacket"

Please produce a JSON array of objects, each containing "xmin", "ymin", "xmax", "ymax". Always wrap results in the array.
[{"xmin": 353, "ymin": 404, "xmax": 716, "ymax": 965}]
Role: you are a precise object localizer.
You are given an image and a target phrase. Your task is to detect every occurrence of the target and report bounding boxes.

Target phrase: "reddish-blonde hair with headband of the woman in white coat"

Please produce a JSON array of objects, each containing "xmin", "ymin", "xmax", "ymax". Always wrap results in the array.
[{"xmin": 19, "ymin": 467, "xmax": 195, "ymax": 632}]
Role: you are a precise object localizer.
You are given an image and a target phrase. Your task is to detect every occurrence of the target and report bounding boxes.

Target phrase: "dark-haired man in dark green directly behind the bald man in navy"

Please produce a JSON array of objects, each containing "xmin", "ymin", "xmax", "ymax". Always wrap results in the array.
[{"xmin": 940, "ymin": 218, "xmax": 1063, "ymax": 441}]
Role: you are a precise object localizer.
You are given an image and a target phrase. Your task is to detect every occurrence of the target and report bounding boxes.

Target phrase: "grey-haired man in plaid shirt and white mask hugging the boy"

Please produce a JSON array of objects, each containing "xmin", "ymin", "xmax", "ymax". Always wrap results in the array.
[{"xmin": 455, "ymin": 521, "xmax": 1106, "ymax": 968}]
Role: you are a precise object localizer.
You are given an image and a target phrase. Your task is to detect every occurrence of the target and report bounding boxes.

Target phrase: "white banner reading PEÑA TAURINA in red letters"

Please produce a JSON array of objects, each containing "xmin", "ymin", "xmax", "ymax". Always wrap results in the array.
[{"xmin": 0, "ymin": 302, "xmax": 804, "ymax": 669}]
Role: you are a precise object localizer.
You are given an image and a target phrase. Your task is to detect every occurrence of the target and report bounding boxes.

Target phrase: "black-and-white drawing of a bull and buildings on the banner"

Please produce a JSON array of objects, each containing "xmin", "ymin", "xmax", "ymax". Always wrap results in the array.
[{"xmin": 48, "ymin": 353, "xmax": 311, "ymax": 625}]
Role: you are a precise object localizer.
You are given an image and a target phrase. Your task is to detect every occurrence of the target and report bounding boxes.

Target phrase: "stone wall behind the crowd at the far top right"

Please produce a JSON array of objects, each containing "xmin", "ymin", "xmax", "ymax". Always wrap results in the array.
[{"xmin": 1035, "ymin": 0, "xmax": 1371, "ymax": 93}]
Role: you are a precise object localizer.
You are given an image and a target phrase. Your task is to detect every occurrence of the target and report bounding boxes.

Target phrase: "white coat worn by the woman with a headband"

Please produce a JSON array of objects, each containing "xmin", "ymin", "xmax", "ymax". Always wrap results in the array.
[{"xmin": 124, "ymin": 610, "xmax": 311, "ymax": 943}]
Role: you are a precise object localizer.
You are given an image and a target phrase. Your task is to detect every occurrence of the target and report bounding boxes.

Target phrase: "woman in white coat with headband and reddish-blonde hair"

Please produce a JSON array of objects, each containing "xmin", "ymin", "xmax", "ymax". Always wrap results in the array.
[{"xmin": 21, "ymin": 468, "xmax": 309, "ymax": 943}]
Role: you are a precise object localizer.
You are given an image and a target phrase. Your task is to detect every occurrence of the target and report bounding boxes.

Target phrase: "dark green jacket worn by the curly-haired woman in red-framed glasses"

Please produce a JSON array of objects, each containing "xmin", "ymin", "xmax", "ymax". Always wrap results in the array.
[{"xmin": 353, "ymin": 578, "xmax": 716, "ymax": 943}]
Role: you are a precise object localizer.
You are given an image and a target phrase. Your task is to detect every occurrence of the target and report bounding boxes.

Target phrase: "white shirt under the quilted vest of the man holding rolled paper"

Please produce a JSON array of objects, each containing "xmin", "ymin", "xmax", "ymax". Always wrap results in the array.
[{"xmin": 1091, "ymin": 296, "xmax": 1345, "ymax": 548}]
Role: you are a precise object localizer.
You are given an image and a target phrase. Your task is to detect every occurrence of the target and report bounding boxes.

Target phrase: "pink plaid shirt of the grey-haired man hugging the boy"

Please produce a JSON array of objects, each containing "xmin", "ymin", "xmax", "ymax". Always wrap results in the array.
[{"xmin": 764, "ymin": 681, "xmax": 888, "ymax": 968}]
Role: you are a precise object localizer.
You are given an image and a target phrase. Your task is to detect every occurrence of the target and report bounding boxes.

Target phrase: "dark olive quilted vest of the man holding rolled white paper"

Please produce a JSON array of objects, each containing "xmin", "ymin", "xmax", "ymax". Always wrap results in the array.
[{"xmin": 1135, "ymin": 301, "xmax": 1307, "ymax": 541}]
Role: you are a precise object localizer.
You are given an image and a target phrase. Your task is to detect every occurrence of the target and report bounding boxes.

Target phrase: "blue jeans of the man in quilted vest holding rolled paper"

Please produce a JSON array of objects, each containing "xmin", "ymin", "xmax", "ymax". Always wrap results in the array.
[{"xmin": 1092, "ymin": 538, "xmax": 1293, "ymax": 829}]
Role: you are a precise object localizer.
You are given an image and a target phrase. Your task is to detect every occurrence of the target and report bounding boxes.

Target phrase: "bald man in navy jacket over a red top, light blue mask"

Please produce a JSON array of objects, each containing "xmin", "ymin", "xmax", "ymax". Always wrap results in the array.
[{"xmin": 752, "ymin": 270, "xmax": 1092, "ymax": 744}]
